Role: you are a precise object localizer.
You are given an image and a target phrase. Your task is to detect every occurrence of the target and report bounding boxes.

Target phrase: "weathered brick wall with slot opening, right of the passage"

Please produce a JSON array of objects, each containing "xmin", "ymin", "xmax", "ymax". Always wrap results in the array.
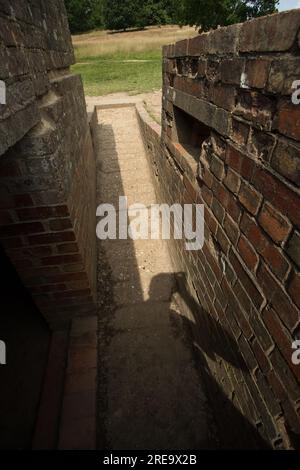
[{"xmin": 139, "ymin": 10, "xmax": 300, "ymax": 447}]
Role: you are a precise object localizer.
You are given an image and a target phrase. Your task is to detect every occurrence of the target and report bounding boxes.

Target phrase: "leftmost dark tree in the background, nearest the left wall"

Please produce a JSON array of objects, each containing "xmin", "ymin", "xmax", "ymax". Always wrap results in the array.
[{"xmin": 65, "ymin": 0, "xmax": 103, "ymax": 33}]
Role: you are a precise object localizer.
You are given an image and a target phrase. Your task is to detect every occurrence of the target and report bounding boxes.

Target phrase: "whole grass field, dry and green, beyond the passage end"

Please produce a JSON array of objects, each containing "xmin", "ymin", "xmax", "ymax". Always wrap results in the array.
[{"xmin": 73, "ymin": 26, "xmax": 197, "ymax": 96}]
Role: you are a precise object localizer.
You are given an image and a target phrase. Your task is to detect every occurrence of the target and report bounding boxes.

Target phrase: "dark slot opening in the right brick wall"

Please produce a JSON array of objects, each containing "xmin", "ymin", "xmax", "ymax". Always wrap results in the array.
[{"xmin": 173, "ymin": 106, "xmax": 211, "ymax": 161}]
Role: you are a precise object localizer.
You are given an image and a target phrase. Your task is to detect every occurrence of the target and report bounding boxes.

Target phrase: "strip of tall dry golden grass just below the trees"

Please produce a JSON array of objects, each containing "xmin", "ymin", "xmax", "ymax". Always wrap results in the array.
[{"xmin": 73, "ymin": 26, "xmax": 197, "ymax": 61}]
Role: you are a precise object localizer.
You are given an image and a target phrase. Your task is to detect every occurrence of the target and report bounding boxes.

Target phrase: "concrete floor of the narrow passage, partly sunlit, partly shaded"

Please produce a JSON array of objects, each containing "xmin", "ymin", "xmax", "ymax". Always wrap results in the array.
[{"xmin": 96, "ymin": 106, "xmax": 212, "ymax": 450}]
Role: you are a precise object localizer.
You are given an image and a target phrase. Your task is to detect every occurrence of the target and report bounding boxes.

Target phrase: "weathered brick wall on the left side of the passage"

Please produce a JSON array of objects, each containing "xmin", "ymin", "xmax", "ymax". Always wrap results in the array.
[{"xmin": 0, "ymin": 0, "xmax": 96, "ymax": 328}]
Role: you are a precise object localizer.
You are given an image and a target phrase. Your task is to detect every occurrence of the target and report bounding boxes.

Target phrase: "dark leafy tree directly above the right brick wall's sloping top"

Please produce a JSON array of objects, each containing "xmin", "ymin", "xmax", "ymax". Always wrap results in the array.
[{"xmin": 174, "ymin": 0, "xmax": 279, "ymax": 31}]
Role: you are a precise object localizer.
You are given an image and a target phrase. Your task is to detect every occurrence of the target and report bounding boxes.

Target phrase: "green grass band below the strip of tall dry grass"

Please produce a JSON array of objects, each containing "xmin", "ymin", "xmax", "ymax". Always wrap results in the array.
[{"xmin": 73, "ymin": 49, "xmax": 162, "ymax": 96}]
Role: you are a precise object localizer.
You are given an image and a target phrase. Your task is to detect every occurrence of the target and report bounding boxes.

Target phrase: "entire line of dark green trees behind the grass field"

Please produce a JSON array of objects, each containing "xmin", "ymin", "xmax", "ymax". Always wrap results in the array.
[{"xmin": 65, "ymin": 0, "xmax": 279, "ymax": 33}]
